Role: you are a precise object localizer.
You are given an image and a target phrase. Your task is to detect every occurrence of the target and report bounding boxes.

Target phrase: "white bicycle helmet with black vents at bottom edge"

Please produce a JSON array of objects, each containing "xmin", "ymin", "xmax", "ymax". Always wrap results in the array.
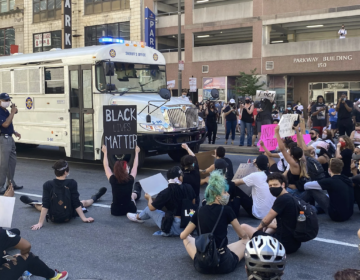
[{"xmin": 245, "ymin": 235, "xmax": 286, "ymax": 280}]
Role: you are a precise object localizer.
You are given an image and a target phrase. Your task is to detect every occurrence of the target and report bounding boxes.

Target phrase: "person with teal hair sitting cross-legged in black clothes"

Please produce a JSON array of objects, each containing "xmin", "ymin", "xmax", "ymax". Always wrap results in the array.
[{"xmin": 180, "ymin": 171, "xmax": 249, "ymax": 274}]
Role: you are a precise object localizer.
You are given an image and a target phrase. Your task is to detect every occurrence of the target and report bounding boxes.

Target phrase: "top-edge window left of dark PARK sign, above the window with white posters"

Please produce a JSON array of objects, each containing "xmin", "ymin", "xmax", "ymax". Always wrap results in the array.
[{"xmin": 33, "ymin": 0, "xmax": 61, "ymax": 23}]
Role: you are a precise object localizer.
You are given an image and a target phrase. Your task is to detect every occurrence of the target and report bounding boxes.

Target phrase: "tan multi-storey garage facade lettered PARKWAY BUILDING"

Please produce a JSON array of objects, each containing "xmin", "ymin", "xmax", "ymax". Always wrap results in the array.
[{"xmin": 144, "ymin": 0, "xmax": 360, "ymax": 111}]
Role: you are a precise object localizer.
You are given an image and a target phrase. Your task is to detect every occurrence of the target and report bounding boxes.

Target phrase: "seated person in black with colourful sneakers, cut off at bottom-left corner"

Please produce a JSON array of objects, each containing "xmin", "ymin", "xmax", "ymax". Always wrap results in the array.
[{"xmin": 0, "ymin": 227, "xmax": 69, "ymax": 280}]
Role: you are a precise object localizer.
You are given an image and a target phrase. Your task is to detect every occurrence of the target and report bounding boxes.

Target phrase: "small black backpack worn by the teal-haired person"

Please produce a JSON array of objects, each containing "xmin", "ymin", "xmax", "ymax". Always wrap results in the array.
[{"xmin": 194, "ymin": 206, "xmax": 224, "ymax": 270}]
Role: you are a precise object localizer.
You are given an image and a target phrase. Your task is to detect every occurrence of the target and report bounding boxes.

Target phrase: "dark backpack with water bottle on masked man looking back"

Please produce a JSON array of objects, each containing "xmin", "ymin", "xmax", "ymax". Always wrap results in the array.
[{"xmin": 292, "ymin": 196, "xmax": 319, "ymax": 242}]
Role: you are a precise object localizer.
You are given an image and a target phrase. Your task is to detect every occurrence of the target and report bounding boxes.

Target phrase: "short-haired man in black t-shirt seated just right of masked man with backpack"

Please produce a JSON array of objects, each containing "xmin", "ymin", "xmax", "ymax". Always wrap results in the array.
[{"xmin": 301, "ymin": 159, "xmax": 354, "ymax": 222}]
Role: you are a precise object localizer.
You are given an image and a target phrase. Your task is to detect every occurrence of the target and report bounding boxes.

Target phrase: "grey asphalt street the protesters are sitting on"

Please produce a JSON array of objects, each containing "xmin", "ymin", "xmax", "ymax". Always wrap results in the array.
[{"xmin": 4, "ymin": 145, "xmax": 360, "ymax": 280}]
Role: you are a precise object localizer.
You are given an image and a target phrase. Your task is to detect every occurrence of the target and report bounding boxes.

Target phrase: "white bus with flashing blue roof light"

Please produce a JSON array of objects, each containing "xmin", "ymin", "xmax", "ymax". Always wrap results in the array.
[{"xmin": 0, "ymin": 41, "xmax": 206, "ymax": 165}]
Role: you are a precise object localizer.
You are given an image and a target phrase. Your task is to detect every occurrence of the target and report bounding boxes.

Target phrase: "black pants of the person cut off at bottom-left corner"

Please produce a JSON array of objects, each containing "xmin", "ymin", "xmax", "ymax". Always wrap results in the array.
[{"xmin": 0, "ymin": 253, "xmax": 56, "ymax": 280}]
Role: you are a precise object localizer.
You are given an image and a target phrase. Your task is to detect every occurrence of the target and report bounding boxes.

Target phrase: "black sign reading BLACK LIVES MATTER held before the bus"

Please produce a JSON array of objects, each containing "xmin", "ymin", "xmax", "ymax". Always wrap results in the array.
[{"xmin": 103, "ymin": 105, "xmax": 137, "ymax": 154}]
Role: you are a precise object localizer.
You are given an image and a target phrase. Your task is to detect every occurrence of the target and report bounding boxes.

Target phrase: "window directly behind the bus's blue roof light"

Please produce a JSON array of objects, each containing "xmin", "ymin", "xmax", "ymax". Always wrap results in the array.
[{"xmin": 85, "ymin": 21, "xmax": 130, "ymax": 46}]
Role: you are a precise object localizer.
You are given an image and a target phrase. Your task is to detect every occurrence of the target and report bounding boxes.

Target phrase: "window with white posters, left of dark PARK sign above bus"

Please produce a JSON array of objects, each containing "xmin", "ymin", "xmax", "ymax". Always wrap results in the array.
[{"xmin": 33, "ymin": 30, "xmax": 61, "ymax": 52}]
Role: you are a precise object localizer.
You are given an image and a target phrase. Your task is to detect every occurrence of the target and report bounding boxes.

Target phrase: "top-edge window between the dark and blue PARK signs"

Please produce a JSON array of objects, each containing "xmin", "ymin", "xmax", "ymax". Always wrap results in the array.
[{"xmin": 85, "ymin": 0, "xmax": 130, "ymax": 15}]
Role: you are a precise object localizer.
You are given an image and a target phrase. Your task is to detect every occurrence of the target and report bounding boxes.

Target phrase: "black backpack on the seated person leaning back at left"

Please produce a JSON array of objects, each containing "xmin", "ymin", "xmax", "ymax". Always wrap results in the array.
[{"xmin": 47, "ymin": 186, "xmax": 74, "ymax": 223}]
